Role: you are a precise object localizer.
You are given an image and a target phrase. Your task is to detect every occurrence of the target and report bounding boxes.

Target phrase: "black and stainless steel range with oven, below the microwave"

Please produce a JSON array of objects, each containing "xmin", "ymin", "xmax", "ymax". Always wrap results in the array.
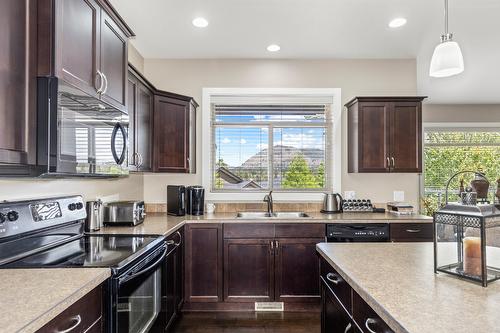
[{"xmin": 0, "ymin": 196, "xmax": 169, "ymax": 333}]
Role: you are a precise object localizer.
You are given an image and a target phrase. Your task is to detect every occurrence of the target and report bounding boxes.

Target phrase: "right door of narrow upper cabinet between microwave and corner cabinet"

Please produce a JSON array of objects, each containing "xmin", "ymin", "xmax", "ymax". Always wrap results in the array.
[{"xmin": 135, "ymin": 83, "xmax": 154, "ymax": 171}]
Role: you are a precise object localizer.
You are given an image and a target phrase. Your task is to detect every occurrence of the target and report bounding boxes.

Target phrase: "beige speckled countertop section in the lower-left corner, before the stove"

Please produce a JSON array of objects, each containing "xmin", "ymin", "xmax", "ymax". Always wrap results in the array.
[{"xmin": 0, "ymin": 268, "xmax": 111, "ymax": 332}]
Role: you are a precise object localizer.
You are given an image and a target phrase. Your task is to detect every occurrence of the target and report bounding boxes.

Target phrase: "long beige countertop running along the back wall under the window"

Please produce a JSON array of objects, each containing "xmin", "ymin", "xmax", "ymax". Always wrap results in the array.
[{"xmin": 95, "ymin": 212, "xmax": 432, "ymax": 236}]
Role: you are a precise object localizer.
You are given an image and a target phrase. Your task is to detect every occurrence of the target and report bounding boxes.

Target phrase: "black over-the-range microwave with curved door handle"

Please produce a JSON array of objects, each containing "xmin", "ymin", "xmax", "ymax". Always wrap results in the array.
[{"xmin": 36, "ymin": 77, "xmax": 128, "ymax": 177}]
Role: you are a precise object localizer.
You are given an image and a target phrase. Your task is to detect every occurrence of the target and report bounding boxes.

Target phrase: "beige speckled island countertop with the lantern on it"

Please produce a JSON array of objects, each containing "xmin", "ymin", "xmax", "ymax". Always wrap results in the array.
[{"xmin": 317, "ymin": 243, "xmax": 500, "ymax": 333}]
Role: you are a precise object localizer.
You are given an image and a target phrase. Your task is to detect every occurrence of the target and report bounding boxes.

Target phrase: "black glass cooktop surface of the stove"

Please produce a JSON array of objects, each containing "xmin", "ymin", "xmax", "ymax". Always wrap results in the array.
[{"xmin": 2, "ymin": 235, "xmax": 162, "ymax": 268}]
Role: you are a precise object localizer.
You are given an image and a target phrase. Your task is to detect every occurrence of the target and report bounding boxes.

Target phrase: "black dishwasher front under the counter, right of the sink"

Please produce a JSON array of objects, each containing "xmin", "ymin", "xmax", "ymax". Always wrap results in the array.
[{"xmin": 326, "ymin": 223, "xmax": 389, "ymax": 243}]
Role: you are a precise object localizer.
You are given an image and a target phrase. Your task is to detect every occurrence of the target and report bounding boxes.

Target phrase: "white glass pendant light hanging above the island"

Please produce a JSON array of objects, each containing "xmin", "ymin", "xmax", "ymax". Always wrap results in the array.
[{"xmin": 429, "ymin": 0, "xmax": 464, "ymax": 77}]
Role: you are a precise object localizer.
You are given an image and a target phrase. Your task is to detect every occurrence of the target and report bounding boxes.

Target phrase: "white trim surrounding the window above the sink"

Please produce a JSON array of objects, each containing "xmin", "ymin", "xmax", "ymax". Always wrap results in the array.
[{"xmin": 201, "ymin": 88, "xmax": 342, "ymax": 202}]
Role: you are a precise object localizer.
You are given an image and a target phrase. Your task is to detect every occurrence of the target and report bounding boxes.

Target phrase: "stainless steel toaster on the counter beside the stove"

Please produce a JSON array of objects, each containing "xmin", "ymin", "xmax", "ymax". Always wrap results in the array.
[{"xmin": 104, "ymin": 201, "xmax": 146, "ymax": 225}]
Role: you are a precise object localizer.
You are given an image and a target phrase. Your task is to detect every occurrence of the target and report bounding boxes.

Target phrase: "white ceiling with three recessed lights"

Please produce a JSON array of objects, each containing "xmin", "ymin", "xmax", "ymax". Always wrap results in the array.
[{"xmin": 111, "ymin": 0, "xmax": 500, "ymax": 103}]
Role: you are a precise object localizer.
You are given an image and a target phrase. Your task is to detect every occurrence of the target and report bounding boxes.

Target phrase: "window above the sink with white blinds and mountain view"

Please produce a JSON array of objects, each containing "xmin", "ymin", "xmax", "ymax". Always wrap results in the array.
[{"xmin": 204, "ymin": 87, "xmax": 340, "ymax": 200}]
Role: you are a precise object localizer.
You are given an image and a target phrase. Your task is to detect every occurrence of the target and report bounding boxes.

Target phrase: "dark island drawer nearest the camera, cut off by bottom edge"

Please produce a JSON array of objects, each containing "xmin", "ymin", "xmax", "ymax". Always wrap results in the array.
[{"xmin": 352, "ymin": 291, "xmax": 393, "ymax": 333}]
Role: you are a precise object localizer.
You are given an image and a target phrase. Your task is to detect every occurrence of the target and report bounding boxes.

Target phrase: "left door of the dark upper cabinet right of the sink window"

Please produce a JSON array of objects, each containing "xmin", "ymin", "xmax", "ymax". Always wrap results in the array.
[{"xmin": 358, "ymin": 102, "xmax": 390, "ymax": 172}]
